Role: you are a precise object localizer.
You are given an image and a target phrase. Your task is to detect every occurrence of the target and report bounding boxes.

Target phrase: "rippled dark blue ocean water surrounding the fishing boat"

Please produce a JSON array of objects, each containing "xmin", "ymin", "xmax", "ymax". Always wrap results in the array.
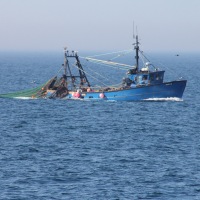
[{"xmin": 0, "ymin": 51, "xmax": 200, "ymax": 200}]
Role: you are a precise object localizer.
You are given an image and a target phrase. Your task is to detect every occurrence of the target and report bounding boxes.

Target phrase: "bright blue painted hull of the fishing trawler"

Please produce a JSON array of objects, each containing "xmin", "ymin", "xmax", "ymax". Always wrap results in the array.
[{"xmin": 66, "ymin": 80, "xmax": 187, "ymax": 101}]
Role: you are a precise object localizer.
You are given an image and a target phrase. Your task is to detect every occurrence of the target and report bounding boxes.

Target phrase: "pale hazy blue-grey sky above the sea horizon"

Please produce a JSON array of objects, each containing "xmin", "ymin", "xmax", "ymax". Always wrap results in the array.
[{"xmin": 0, "ymin": 0, "xmax": 200, "ymax": 52}]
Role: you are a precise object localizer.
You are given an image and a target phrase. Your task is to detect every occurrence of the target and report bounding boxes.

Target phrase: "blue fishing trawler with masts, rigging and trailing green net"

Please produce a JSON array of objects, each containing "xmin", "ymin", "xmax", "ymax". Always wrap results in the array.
[{"xmin": 0, "ymin": 36, "xmax": 187, "ymax": 101}]
